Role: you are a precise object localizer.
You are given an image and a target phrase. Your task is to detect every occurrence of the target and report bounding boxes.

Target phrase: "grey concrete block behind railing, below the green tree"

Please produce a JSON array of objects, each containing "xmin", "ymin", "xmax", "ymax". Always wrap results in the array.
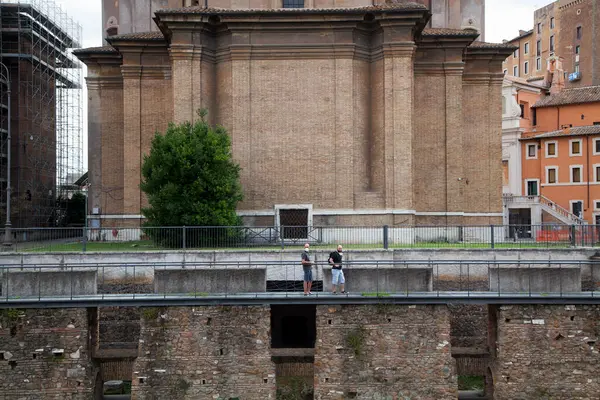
[{"xmin": 154, "ymin": 268, "xmax": 267, "ymax": 293}]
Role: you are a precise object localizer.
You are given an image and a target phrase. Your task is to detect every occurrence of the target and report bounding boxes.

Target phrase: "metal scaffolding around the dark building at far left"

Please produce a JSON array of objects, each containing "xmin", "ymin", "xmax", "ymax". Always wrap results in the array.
[{"xmin": 0, "ymin": 0, "xmax": 83, "ymax": 228}]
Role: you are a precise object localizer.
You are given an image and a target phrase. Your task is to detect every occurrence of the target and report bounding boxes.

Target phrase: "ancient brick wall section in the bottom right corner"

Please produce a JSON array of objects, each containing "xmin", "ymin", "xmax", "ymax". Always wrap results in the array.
[{"xmin": 490, "ymin": 305, "xmax": 600, "ymax": 400}]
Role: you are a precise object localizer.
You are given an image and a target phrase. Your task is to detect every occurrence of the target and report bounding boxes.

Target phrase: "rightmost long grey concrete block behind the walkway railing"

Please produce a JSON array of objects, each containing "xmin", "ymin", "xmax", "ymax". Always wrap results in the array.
[{"xmin": 489, "ymin": 265, "xmax": 581, "ymax": 293}]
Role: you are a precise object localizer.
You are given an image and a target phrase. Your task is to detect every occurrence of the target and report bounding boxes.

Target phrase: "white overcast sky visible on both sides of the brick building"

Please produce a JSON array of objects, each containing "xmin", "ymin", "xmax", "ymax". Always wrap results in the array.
[{"xmin": 54, "ymin": 0, "xmax": 553, "ymax": 170}]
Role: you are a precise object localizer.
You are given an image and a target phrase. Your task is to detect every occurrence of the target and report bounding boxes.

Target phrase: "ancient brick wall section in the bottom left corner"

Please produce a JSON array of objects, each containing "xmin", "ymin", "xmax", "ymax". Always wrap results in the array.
[{"xmin": 0, "ymin": 308, "xmax": 95, "ymax": 400}]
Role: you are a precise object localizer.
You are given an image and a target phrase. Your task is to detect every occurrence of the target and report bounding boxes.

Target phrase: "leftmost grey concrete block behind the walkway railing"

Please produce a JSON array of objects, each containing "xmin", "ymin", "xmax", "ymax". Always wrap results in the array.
[{"xmin": 2, "ymin": 269, "xmax": 98, "ymax": 297}]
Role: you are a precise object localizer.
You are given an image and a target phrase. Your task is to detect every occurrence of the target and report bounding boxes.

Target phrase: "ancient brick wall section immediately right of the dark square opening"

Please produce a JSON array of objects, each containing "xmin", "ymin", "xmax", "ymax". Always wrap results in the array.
[{"xmin": 315, "ymin": 305, "xmax": 458, "ymax": 400}]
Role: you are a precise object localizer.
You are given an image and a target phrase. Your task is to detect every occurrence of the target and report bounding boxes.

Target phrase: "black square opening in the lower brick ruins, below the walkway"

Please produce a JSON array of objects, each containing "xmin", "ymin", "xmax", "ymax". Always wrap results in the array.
[{"xmin": 271, "ymin": 305, "xmax": 316, "ymax": 348}]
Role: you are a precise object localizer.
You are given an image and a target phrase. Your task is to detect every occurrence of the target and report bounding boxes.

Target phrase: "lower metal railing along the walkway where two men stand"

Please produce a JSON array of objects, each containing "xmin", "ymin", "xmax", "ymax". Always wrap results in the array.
[{"xmin": 0, "ymin": 260, "xmax": 600, "ymax": 307}]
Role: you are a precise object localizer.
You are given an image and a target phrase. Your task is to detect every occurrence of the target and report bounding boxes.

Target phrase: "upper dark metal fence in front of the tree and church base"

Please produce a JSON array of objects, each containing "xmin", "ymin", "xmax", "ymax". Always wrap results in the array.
[{"xmin": 0, "ymin": 225, "xmax": 600, "ymax": 252}]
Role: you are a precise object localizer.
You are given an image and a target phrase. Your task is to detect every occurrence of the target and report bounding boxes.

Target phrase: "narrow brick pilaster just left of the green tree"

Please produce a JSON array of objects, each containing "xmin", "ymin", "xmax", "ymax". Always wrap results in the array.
[{"xmin": 121, "ymin": 65, "xmax": 142, "ymax": 215}]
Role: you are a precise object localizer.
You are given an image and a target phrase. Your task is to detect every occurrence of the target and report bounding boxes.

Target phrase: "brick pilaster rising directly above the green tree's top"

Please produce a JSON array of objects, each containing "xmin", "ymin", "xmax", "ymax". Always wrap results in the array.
[{"xmin": 170, "ymin": 43, "xmax": 195, "ymax": 124}]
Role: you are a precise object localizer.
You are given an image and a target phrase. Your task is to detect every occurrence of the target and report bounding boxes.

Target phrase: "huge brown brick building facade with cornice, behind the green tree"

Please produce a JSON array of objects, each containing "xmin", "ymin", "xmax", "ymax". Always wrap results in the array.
[{"xmin": 77, "ymin": 2, "xmax": 514, "ymax": 226}]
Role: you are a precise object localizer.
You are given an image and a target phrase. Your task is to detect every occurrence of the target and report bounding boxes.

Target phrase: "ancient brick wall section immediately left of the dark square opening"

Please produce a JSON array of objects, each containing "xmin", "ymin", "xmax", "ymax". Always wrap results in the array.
[{"xmin": 132, "ymin": 306, "xmax": 275, "ymax": 400}]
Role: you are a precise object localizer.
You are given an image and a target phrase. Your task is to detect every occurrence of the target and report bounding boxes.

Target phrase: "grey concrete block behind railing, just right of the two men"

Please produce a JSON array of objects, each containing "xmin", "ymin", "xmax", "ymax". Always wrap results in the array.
[{"xmin": 323, "ymin": 267, "xmax": 433, "ymax": 293}]
